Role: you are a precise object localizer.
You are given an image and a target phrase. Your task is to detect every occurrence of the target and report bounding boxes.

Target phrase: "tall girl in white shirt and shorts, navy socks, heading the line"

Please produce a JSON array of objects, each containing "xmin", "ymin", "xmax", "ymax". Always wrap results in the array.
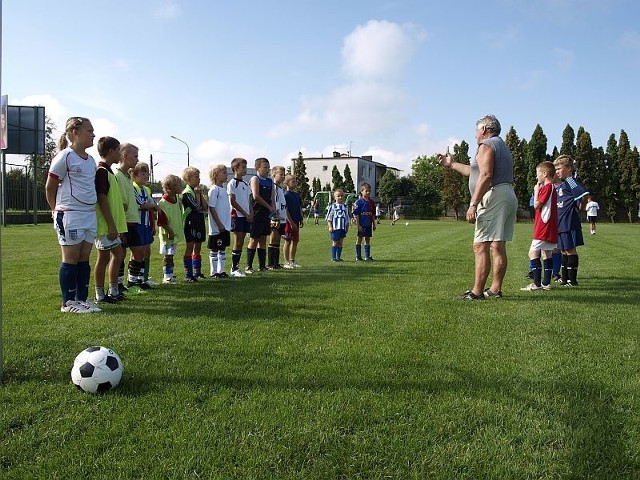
[{"xmin": 45, "ymin": 117, "xmax": 100, "ymax": 313}]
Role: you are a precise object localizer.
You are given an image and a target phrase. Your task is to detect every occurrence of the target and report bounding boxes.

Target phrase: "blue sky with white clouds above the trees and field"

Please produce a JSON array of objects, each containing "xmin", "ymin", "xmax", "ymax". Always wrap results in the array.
[{"xmin": 1, "ymin": 0, "xmax": 640, "ymax": 179}]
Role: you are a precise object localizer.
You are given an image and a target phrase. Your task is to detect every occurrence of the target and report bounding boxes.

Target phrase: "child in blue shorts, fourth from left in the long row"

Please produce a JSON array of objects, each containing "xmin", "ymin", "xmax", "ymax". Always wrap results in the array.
[{"xmin": 129, "ymin": 162, "xmax": 157, "ymax": 285}]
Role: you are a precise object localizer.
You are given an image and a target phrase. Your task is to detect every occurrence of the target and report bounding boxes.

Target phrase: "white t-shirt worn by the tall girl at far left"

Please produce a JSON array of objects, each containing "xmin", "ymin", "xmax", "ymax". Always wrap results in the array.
[{"xmin": 49, "ymin": 147, "xmax": 97, "ymax": 212}]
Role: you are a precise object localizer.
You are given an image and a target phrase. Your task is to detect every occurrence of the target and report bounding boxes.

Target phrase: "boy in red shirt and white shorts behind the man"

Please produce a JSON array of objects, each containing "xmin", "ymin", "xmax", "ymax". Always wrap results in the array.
[{"xmin": 520, "ymin": 162, "xmax": 558, "ymax": 297}]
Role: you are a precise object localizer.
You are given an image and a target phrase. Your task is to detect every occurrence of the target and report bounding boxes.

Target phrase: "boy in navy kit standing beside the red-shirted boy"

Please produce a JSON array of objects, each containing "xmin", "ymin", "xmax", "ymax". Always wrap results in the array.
[{"xmin": 553, "ymin": 155, "xmax": 589, "ymax": 287}]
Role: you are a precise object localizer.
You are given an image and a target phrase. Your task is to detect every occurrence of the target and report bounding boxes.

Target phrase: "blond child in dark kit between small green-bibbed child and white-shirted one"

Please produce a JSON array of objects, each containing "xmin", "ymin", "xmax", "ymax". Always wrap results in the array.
[{"xmin": 182, "ymin": 167, "xmax": 207, "ymax": 283}]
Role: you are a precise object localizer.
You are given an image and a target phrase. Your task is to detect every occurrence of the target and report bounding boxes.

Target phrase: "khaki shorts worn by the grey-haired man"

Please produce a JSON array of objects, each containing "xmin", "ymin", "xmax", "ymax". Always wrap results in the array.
[{"xmin": 473, "ymin": 183, "xmax": 518, "ymax": 243}]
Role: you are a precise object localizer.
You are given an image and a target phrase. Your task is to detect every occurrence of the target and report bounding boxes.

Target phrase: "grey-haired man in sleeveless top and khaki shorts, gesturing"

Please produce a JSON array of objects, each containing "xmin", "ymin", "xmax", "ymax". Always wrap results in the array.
[{"xmin": 438, "ymin": 115, "xmax": 518, "ymax": 300}]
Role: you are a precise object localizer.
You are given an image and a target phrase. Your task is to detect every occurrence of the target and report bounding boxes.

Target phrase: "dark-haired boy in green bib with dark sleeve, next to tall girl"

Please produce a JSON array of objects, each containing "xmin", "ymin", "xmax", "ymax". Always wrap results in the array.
[{"xmin": 93, "ymin": 137, "xmax": 127, "ymax": 304}]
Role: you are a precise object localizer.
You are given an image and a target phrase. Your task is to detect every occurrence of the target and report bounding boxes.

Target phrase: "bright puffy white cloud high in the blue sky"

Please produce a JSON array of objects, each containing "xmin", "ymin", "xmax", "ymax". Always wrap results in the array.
[{"xmin": 342, "ymin": 20, "xmax": 426, "ymax": 80}]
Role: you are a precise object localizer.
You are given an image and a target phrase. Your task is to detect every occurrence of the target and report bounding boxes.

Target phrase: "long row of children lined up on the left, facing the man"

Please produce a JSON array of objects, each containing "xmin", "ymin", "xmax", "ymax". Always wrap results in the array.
[{"xmin": 45, "ymin": 117, "xmax": 303, "ymax": 313}]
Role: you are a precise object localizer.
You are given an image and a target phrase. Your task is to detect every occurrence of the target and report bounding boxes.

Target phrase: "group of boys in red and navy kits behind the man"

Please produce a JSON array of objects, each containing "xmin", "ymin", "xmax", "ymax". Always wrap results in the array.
[{"xmin": 521, "ymin": 155, "xmax": 597, "ymax": 292}]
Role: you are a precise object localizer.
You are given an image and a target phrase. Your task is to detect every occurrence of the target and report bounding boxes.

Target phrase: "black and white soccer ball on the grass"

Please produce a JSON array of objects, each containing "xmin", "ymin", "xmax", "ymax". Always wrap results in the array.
[{"xmin": 71, "ymin": 347, "xmax": 124, "ymax": 393}]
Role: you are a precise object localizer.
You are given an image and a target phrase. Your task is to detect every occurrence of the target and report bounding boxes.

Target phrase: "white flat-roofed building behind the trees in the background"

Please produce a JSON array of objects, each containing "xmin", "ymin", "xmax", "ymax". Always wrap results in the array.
[{"xmin": 291, "ymin": 152, "xmax": 400, "ymax": 200}]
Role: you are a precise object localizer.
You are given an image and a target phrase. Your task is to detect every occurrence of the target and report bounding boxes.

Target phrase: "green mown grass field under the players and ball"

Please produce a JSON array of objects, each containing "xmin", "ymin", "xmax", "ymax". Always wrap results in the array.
[{"xmin": 0, "ymin": 221, "xmax": 640, "ymax": 479}]
